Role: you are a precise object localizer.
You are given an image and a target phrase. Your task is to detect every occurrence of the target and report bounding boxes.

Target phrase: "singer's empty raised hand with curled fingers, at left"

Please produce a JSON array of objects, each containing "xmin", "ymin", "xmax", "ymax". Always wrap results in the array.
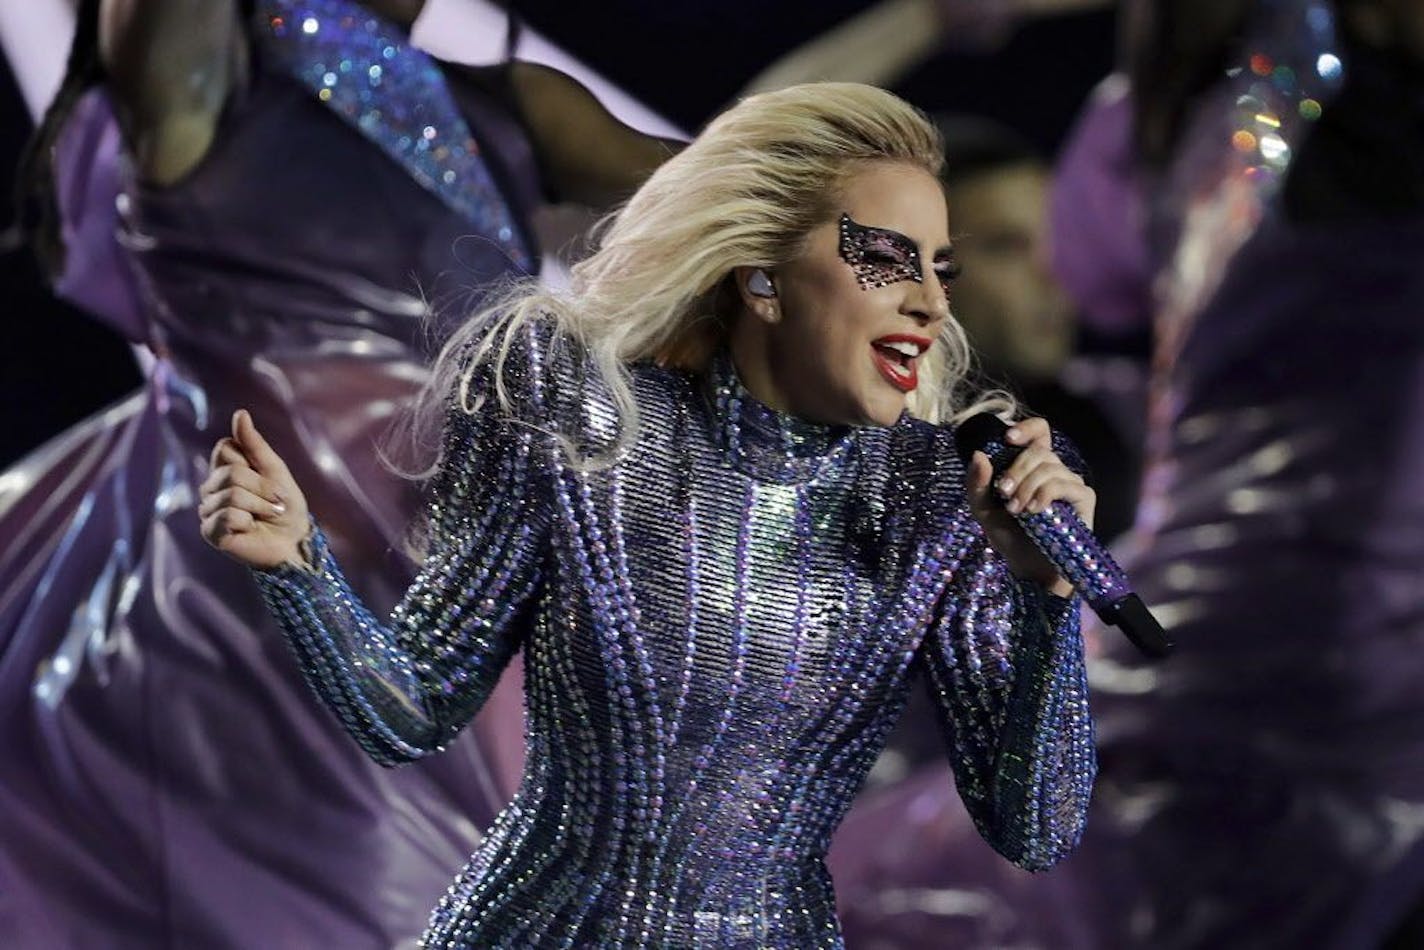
[{"xmin": 198, "ymin": 409, "xmax": 309, "ymax": 570}]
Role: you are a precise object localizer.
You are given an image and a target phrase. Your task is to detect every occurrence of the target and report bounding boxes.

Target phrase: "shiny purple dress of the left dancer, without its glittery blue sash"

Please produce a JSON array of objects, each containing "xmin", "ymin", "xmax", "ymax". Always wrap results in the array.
[{"xmin": 0, "ymin": 14, "xmax": 538, "ymax": 950}]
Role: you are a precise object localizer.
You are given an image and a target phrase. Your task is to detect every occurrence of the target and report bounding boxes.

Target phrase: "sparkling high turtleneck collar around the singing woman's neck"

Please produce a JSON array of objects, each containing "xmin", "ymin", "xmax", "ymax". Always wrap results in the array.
[{"xmin": 708, "ymin": 349, "xmax": 857, "ymax": 484}]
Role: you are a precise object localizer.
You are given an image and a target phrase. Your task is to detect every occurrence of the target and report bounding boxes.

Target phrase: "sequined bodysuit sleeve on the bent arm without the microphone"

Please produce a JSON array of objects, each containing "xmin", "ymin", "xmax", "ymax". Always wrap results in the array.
[{"xmin": 253, "ymin": 346, "xmax": 550, "ymax": 765}]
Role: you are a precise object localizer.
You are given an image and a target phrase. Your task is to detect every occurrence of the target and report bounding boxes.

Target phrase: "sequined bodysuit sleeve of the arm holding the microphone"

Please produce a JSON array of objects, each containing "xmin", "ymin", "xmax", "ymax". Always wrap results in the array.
[{"xmin": 920, "ymin": 516, "xmax": 1096, "ymax": 870}]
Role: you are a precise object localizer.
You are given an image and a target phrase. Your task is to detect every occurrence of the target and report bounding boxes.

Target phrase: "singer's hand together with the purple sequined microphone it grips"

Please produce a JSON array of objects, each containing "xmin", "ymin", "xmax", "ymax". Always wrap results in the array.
[{"xmin": 956, "ymin": 413, "xmax": 1172, "ymax": 657}]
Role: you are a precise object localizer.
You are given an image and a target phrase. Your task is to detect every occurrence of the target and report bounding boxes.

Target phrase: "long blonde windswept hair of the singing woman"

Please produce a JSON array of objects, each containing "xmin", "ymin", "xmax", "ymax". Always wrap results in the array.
[{"xmin": 407, "ymin": 83, "xmax": 1011, "ymax": 475}]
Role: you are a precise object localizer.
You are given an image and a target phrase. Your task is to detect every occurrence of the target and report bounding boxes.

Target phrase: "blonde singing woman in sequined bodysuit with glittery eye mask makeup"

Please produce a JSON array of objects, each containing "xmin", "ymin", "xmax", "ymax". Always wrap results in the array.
[{"xmin": 201, "ymin": 84, "xmax": 1095, "ymax": 947}]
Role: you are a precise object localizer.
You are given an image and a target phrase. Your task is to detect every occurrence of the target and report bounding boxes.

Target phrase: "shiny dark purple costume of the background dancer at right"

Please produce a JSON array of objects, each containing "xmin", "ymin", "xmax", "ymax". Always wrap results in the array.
[{"xmin": 833, "ymin": 3, "xmax": 1424, "ymax": 950}]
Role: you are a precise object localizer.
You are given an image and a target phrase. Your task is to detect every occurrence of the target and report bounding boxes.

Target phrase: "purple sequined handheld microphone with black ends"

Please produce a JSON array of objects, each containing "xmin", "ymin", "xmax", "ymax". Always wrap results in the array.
[{"xmin": 954, "ymin": 413, "xmax": 1172, "ymax": 657}]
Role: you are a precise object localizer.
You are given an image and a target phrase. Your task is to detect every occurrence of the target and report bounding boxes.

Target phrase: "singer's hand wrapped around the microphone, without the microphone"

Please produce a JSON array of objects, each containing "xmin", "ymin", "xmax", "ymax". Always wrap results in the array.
[{"xmin": 964, "ymin": 419, "xmax": 1098, "ymax": 597}]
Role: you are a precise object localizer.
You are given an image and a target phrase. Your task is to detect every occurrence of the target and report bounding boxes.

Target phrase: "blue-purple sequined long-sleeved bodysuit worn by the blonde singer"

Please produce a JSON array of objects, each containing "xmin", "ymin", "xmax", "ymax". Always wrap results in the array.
[{"xmin": 258, "ymin": 335, "xmax": 1095, "ymax": 947}]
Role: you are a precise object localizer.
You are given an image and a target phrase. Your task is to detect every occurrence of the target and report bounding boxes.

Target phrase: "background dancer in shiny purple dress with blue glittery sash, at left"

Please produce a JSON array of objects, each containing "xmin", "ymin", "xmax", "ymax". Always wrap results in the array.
[{"xmin": 0, "ymin": 0, "xmax": 666, "ymax": 949}]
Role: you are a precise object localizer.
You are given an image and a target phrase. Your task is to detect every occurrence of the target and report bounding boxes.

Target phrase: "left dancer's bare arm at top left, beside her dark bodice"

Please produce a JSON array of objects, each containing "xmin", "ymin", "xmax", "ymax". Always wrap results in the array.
[{"xmin": 98, "ymin": 0, "xmax": 246, "ymax": 185}]
